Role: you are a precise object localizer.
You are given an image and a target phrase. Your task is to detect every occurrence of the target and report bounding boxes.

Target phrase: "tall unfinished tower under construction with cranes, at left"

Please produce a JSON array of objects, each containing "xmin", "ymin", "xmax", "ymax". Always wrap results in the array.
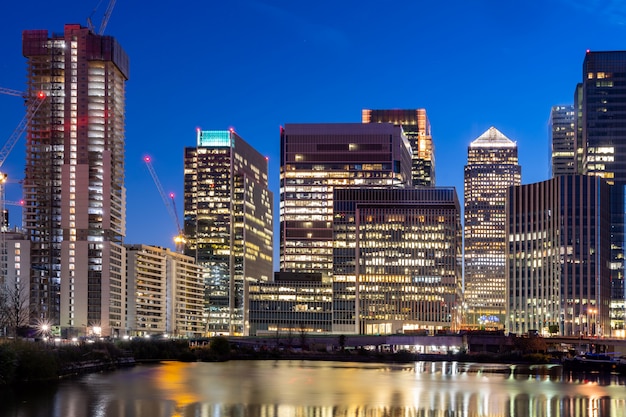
[{"xmin": 22, "ymin": 25, "xmax": 129, "ymax": 336}]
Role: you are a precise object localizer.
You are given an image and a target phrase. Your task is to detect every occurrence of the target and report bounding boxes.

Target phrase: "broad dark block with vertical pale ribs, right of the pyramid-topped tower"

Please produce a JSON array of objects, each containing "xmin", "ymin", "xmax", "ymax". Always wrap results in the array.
[{"xmin": 506, "ymin": 175, "xmax": 611, "ymax": 336}]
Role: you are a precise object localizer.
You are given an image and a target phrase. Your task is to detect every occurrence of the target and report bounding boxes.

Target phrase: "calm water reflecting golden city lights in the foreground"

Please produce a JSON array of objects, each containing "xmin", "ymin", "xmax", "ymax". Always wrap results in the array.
[{"xmin": 0, "ymin": 361, "xmax": 626, "ymax": 417}]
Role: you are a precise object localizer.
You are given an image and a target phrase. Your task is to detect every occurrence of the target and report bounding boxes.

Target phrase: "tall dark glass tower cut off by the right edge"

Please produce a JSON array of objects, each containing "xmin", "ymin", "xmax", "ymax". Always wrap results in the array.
[{"xmin": 575, "ymin": 51, "xmax": 626, "ymax": 336}]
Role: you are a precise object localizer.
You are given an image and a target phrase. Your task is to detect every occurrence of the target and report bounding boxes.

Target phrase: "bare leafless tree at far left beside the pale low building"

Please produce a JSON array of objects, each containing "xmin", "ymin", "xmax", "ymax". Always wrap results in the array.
[{"xmin": 0, "ymin": 281, "xmax": 30, "ymax": 337}]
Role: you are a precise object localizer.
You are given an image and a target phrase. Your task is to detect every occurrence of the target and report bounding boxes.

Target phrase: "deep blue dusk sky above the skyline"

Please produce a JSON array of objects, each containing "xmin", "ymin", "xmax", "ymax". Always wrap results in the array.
[{"xmin": 0, "ymin": 0, "xmax": 626, "ymax": 267}]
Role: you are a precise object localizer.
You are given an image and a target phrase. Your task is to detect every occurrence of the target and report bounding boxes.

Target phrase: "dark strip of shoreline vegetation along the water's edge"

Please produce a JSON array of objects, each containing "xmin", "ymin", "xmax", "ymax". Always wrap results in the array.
[{"xmin": 0, "ymin": 336, "xmax": 616, "ymax": 389}]
